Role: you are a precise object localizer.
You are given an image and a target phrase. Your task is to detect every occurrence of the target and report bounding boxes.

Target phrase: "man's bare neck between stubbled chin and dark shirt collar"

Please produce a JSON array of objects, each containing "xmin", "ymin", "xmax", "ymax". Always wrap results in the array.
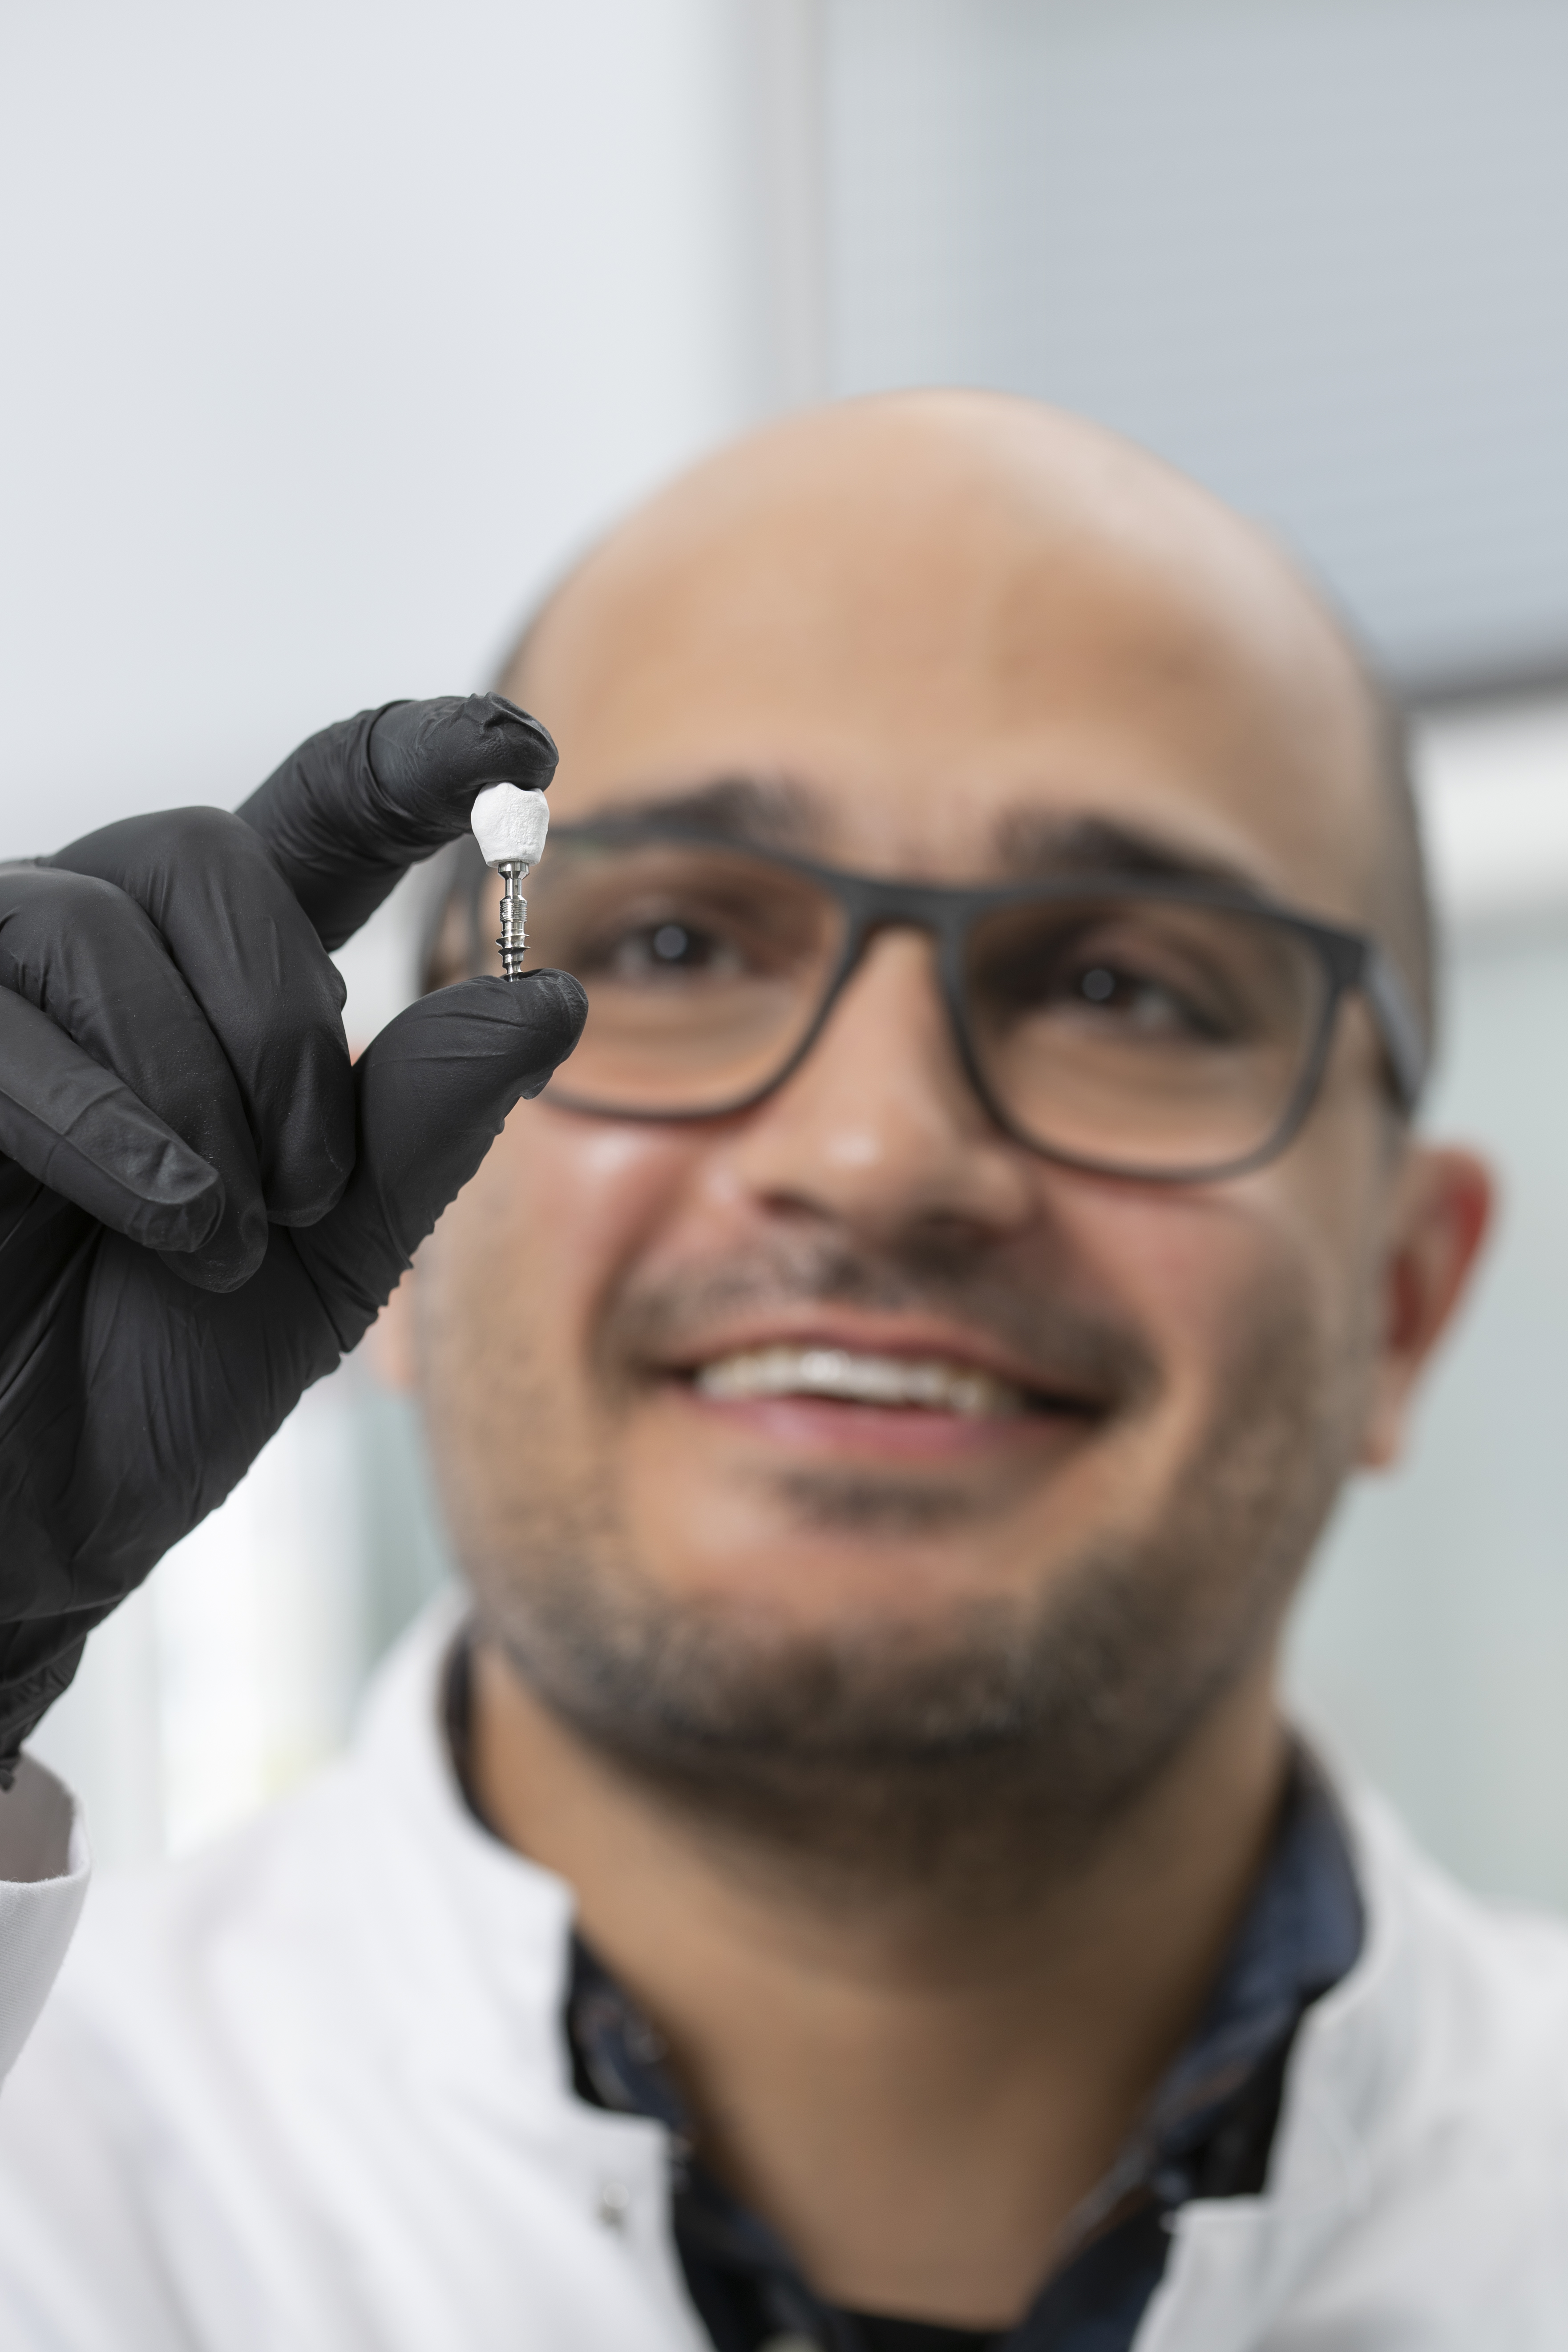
[{"xmin": 473, "ymin": 1644, "xmax": 1284, "ymax": 2326}]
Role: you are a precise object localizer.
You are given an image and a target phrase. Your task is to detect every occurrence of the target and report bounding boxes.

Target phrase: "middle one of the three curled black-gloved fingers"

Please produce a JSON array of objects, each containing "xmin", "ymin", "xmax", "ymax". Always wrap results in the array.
[{"xmin": 0, "ymin": 865, "xmax": 268, "ymax": 1291}]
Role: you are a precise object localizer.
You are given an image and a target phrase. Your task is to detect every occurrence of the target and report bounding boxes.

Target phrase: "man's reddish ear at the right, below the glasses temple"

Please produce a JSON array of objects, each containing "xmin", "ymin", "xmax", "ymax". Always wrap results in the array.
[{"xmin": 1361, "ymin": 1143, "xmax": 1495, "ymax": 1470}]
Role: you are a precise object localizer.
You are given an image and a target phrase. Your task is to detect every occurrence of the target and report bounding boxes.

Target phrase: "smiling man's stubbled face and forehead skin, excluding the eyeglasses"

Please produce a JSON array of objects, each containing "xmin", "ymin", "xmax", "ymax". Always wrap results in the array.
[{"xmin": 416, "ymin": 409, "xmax": 1439, "ymax": 1853}]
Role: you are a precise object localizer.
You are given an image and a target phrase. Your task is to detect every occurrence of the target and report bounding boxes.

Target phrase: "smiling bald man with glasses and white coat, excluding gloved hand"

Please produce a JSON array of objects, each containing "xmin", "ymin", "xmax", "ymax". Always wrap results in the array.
[{"xmin": 0, "ymin": 395, "xmax": 1568, "ymax": 2352}]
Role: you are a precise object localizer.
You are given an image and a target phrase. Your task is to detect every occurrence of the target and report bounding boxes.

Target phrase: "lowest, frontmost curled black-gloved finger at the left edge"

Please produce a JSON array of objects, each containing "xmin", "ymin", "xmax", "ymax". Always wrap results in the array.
[{"xmin": 0, "ymin": 988, "xmax": 223, "ymax": 1253}]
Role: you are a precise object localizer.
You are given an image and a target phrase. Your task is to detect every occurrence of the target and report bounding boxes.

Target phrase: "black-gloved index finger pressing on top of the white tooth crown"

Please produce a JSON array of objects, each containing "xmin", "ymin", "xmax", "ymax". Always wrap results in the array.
[{"xmin": 240, "ymin": 694, "xmax": 557, "ymax": 948}]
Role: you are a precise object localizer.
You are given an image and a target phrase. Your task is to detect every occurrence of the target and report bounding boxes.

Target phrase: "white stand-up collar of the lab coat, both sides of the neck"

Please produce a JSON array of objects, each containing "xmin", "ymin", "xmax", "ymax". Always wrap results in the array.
[{"xmin": 334, "ymin": 1595, "xmax": 1495, "ymax": 2352}]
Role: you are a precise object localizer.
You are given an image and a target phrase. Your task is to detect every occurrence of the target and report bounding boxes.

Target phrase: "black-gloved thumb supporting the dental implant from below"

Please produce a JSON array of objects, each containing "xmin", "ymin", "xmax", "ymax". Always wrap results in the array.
[{"xmin": 294, "ymin": 971, "xmax": 588, "ymax": 1348}]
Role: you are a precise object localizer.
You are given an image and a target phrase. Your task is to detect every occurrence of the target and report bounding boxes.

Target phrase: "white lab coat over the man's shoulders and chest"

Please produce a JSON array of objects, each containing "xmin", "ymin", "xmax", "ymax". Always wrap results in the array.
[{"xmin": 0, "ymin": 1613, "xmax": 1568, "ymax": 2352}]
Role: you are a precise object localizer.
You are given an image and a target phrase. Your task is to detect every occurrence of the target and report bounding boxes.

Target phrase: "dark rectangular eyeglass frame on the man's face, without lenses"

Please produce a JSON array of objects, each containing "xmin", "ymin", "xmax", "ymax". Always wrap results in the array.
[{"xmin": 491, "ymin": 819, "xmax": 1427, "ymax": 1183}]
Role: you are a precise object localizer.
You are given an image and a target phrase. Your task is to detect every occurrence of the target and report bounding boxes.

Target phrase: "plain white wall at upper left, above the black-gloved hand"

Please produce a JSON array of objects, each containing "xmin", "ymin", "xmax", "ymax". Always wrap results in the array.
[{"xmin": 0, "ymin": 0, "xmax": 769, "ymax": 852}]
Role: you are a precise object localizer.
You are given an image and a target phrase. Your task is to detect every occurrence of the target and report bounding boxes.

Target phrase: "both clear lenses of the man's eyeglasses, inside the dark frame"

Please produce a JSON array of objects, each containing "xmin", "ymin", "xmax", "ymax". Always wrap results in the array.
[{"xmin": 529, "ymin": 840, "xmax": 1328, "ymax": 1176}]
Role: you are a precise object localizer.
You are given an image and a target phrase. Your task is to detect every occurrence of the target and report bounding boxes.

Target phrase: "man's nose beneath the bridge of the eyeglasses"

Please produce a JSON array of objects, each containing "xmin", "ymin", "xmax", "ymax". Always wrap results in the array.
[{"xmin": 729, "ymin": 929, "xmax": 1037, "ymax": 1242}]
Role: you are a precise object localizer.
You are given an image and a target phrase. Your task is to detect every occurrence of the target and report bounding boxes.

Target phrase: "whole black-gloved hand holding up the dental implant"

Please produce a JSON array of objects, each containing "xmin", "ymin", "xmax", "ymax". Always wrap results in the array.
[{"xmin": 0, "ymin": 694, "xmax": 588, "ymax": 1783}]
